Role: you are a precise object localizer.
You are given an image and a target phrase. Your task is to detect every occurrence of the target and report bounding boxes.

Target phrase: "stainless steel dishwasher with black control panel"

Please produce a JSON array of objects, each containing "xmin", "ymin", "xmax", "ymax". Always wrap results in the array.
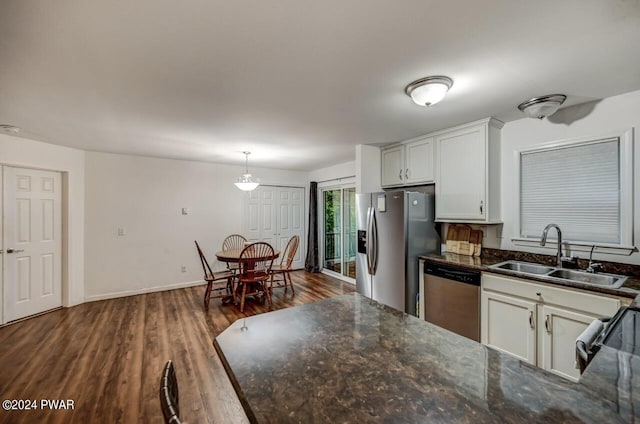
[{"xmin": 423, "ymin": 262, "xmax": 481, "ymax": 342}]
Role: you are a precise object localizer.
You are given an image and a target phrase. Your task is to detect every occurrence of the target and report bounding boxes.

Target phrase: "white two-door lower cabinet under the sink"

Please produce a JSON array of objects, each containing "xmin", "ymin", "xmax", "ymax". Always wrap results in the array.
[{"xmin": 480, "ymin": 273, "xmax": 622, "ymax": 381}]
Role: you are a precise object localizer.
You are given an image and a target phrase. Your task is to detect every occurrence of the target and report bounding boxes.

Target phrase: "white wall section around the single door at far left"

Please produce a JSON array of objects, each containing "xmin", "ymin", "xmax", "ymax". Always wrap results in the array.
[{"xmin": 0, "ymin": 134, "xmax": 85, "ymax": 306}]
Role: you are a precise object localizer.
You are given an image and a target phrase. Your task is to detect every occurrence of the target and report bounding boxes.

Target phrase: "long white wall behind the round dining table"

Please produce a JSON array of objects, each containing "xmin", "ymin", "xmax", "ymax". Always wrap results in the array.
[{"xmin": 85, "ymin": 152, "xmax": 308, "ymax": 300}]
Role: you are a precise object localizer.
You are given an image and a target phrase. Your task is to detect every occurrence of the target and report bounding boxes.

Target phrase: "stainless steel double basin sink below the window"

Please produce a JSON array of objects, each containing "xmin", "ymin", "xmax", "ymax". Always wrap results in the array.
[{"xmin": 489, "ymin": 261, "xmax": 627, "ymax": 289}]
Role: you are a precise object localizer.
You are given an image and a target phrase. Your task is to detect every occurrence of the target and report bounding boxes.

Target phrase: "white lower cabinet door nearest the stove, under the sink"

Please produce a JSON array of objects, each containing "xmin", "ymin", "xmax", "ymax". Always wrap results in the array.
[{"xmin": 539, "ymin": 305, "xmax": 596, "ymax": 381}]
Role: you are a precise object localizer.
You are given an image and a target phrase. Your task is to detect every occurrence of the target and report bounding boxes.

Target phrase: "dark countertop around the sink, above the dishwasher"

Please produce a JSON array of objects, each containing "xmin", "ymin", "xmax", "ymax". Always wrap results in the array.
[{"xmin": 418, "ymin": 254, "xmax": 640, "ymax": 302}]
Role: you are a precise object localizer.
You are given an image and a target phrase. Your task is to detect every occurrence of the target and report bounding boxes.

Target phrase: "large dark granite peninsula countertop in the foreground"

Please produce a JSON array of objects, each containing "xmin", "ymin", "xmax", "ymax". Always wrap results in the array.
[{"xmin": 214, "ymin": 293, "xmax": 640, "ymax": 424}]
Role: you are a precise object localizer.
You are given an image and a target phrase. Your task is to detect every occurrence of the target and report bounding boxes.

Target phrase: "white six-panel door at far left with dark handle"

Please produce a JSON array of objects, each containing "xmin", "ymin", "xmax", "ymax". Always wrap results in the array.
[{"xmin": 2, "ymin": 166, "xmax": 62, "ymax": 322}]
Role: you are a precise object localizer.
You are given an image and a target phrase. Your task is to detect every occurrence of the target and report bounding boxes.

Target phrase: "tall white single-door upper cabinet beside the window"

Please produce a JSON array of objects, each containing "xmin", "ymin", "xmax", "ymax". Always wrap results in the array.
[{"xmin": 435, "ymin": 118, "xmax": 504, "ymax": 223}]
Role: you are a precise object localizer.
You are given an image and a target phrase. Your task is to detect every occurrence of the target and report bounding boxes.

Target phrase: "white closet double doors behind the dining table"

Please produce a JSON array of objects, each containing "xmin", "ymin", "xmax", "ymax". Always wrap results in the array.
[{"xmin": 243, "ymin": 186, "xmax": 305, "ymax": 269}]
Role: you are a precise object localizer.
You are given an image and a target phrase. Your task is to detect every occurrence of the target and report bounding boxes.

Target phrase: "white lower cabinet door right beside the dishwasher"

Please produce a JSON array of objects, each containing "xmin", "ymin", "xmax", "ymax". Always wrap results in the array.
[{"xmin": 480, "ymin": 290, "xmax": 536, "ymax": 365}]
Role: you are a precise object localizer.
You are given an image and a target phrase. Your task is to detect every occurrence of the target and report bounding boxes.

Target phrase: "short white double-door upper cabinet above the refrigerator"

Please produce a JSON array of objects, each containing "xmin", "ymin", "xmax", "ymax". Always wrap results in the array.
[{"xmin": 381, "ymin": 137, "xmax": 434, "ymax": 187}]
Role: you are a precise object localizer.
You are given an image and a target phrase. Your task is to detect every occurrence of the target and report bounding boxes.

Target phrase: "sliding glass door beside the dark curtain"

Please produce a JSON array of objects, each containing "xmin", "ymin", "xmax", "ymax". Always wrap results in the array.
[{"xmin": 322, "ymin": 187, "xmax": 356, "ymax": 279}]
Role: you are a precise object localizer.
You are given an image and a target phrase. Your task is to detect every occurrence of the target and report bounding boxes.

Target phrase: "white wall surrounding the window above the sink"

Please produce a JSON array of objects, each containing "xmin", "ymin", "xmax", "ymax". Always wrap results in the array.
[{"xmin": 498, "ymin": 91, "xmax": 640, "ymax": 264}]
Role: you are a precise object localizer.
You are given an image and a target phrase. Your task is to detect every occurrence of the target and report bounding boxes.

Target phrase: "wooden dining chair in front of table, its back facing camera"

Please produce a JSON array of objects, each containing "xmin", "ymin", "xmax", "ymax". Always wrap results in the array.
[{"xmin": 237, "ymin": 241, "xmax": 274, "ymax": 312}]
